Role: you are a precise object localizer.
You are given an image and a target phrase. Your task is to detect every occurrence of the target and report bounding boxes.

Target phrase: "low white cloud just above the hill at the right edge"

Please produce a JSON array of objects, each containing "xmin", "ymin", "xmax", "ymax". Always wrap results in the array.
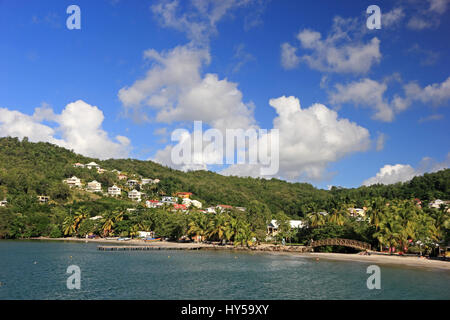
[{"xmin": 362, "ymin": 152, "xmax": 450, "ymax": 186}]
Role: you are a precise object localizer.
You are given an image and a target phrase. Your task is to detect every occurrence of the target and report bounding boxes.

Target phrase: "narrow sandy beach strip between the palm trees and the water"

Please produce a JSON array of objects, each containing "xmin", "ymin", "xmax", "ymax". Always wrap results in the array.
[{"xmin": 9, "ymin": 237, "xmax": 450, "ymax": 271}]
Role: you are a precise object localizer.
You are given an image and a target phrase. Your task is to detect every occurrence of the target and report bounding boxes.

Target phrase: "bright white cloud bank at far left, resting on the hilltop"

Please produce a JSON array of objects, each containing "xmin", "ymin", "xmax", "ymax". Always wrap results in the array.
[{"xmin": 0, "ymin": 100, "xmax": 130, "ymax": 159}]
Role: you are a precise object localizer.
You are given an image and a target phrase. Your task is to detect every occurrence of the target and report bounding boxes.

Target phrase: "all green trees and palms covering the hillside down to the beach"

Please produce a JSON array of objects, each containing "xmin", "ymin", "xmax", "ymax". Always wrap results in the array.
[{"xmin": 0, "ymin": 138, "xmax": 450, "ymax": 255}]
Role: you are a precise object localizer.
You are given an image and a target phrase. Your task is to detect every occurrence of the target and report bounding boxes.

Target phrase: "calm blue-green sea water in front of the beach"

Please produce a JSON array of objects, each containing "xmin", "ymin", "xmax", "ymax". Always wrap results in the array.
[{"xmin": 0, "ymin": 241, "xmax": 450, "ymax": 299}]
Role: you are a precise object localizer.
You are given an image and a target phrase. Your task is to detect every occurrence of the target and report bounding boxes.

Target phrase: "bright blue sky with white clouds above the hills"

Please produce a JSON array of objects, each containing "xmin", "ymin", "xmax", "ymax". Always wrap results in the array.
[{"xmin": 0, "ymin": 0, "xmax": 450, "ymax": 189}]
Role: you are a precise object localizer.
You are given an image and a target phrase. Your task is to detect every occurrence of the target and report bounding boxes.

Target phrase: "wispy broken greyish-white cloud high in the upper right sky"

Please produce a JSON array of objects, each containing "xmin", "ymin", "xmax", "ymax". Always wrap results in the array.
[{"xmin": 281, "ymin": 17, "xmax": 381, "ymax": 74}]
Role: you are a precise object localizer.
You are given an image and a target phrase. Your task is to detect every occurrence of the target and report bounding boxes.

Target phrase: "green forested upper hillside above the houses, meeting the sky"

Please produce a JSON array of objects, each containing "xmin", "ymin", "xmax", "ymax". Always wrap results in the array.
[{"xmin": 0, "ymin": 138, "xmax": 450, "ymax": 217}]
